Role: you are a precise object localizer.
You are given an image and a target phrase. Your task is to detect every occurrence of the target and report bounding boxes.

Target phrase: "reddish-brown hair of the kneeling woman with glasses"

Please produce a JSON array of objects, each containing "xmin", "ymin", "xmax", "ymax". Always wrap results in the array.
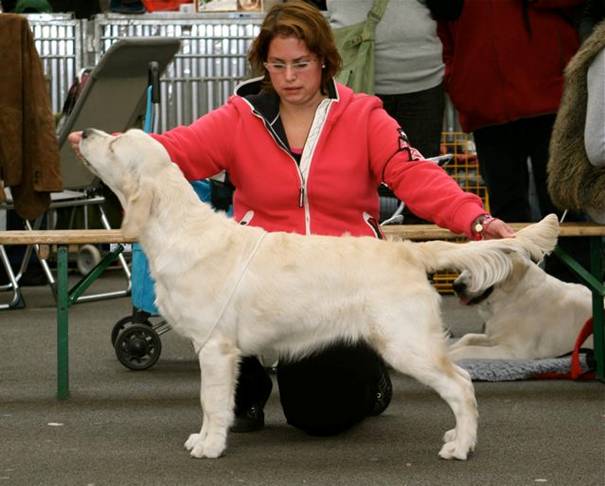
[{"xmin": 248, "ymin": 0, "xmax": 342, "ymax": 93}]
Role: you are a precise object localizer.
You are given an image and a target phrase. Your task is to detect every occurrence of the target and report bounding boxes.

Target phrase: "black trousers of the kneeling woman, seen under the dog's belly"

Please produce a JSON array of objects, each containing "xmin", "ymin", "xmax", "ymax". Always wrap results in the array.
[{"xmin": 235, "ymin": 343, "xmax": 386, "ymax": 435}]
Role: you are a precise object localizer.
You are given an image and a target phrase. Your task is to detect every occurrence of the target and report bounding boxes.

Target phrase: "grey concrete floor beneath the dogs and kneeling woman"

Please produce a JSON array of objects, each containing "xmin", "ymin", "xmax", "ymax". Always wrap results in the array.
[{"xmin": 0, "ymin": 273, "xmax": 605, "ymax": 486}]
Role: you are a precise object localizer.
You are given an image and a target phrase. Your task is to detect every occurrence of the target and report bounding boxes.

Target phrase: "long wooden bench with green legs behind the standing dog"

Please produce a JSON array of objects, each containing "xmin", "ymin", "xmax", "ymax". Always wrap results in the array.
[{"xmin": 0, "ymin": 223, "xmax": 605, "ymax": 400}]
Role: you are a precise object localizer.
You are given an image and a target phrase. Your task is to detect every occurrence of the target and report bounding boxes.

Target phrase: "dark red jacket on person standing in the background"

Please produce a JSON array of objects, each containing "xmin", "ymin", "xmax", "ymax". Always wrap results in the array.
[{"xmin": 439, "ymin": 0, "xmax": 584, "ymax": 132}]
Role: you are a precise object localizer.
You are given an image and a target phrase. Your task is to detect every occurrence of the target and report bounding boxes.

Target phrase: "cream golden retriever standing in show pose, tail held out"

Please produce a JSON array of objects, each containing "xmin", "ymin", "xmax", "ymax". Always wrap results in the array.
[{"xmin": 80, "ymin": 129, "xmax": 558, "ymax": 460}]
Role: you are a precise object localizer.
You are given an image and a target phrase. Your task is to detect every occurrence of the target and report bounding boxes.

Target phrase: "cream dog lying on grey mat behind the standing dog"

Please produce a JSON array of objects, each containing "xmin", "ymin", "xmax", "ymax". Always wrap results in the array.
[{"xmin": 450, "ymin": 255, "xmax": 592, "ymax": 361}]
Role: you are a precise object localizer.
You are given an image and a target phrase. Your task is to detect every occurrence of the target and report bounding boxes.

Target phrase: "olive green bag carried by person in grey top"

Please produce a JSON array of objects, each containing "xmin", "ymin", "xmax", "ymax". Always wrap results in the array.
[{"xmin": 333, "ymin": 0, "xmax": 389, "ymax": 94}]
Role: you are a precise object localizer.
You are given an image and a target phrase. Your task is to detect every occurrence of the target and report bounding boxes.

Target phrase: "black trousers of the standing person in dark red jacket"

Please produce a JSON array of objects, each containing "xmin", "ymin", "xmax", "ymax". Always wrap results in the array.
[{"xmin": 473, "ymin": 115, "xmax": 589, "ymax": 282}]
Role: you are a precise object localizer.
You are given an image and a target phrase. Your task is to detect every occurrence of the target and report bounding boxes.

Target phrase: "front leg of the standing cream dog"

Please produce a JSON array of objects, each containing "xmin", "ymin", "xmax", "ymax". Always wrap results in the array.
[{"xmin": 185, "ymin": 339, "xmax": 239, "ymax": 458}]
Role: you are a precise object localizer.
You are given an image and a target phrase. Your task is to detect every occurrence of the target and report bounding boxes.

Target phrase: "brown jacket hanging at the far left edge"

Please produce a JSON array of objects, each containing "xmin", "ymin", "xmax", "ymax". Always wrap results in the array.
[{"xmin": 0, "ymin": 14, "xmax": 63, "ymax": 219}]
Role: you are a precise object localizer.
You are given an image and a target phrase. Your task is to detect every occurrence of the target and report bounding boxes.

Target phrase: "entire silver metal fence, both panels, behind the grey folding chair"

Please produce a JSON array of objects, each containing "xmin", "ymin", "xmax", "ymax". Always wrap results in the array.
[{"xmin": 27, "ymin": 13, "xmax": 263, "ymax": 131}]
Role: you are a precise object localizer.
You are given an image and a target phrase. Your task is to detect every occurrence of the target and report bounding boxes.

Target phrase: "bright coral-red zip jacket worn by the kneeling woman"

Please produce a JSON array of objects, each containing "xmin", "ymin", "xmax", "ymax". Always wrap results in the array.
[{"xmin": 154, "ymin": 80, "xmax": 486, "ymax": 236}]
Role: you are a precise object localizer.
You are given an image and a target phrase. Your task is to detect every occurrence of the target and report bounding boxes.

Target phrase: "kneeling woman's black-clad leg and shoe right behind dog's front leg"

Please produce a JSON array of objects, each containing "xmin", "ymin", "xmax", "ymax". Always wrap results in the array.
[{"xmin": 231, "ymin": 356, "xmax": 273, "ymax": 432}]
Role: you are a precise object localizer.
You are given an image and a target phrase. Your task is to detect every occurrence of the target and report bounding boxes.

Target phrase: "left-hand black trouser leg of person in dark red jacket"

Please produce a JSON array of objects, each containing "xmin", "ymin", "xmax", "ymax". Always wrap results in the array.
[{"xmin": 473, "ymin": 122, "xmax": 531, "ymax": 222}]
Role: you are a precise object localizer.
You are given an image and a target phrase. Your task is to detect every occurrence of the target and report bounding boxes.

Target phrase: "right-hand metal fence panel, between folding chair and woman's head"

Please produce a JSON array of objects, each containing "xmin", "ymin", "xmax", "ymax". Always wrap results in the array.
[{"xmin": 94, "ymin": 14, "xmax": 262, "ymax": 131}]
